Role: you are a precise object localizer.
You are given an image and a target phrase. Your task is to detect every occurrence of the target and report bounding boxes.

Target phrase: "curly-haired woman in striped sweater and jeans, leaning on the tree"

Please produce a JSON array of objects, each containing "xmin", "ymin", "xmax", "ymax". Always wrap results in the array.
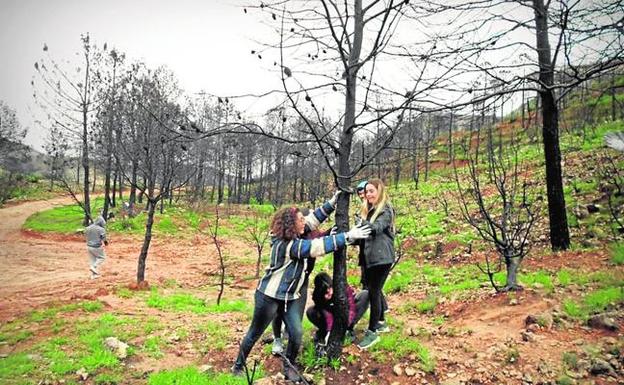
[{"xmin": 232, "ymin": 192, "xmax": 370, "ymax": 382}]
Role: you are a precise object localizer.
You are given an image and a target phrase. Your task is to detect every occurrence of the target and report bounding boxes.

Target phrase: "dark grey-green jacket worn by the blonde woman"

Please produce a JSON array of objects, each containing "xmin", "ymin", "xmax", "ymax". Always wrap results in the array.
[{"xmin": 362, "ymin": 205, "xmax": 394, "ymax": 268}]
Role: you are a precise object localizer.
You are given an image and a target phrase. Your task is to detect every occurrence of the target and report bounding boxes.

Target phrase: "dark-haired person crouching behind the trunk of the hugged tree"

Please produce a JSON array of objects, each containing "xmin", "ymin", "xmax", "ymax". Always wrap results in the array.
[{"xmin": 306, "ymin": 272, "xmax": 368, "ymax": 356}]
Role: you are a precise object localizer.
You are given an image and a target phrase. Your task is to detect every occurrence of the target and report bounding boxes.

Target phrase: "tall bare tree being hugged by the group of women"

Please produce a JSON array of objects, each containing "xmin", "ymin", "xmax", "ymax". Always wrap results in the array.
[{"xmin": 244, "ymin": 0, "xmax": 428, "ymax": 358}]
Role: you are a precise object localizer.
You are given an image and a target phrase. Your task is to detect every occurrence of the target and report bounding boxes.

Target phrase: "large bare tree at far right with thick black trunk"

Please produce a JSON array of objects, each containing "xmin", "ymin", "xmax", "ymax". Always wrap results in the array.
[{"xmin": 428, "ymin": 0, "xmax": 624, "ymax": 250}]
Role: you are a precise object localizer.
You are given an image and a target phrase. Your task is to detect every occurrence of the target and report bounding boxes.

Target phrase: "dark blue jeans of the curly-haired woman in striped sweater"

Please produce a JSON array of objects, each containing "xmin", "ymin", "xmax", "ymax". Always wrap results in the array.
[{"xmin": 236, "ymin": 290, "xmax": 303, "ymax": 368}]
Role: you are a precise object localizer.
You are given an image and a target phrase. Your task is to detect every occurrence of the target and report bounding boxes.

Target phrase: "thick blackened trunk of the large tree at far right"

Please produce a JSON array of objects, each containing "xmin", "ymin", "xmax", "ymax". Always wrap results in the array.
[{"xmin": 533, "ymin": 0, "xmax": 570, "ymax": 250}]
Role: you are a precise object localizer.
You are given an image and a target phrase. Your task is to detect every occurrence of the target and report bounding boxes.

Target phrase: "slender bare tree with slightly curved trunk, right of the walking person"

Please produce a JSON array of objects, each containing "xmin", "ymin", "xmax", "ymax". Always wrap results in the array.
[{"xmin": 116, "ymin": 68, "xmax": 196, "ymax": 283}]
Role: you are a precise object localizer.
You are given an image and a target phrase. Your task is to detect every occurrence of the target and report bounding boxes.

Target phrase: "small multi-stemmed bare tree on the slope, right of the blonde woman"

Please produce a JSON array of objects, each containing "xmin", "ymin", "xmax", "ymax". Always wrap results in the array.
[{"xmin": 454, "ymin": 127, "xmax": 537, "ymax": 292}]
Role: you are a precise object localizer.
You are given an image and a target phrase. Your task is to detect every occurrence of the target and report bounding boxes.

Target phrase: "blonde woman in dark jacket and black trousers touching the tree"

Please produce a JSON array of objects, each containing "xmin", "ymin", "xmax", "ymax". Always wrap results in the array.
[{"xmin": 358, "ymin": 179, "xmax": 394, "ymax": 349}]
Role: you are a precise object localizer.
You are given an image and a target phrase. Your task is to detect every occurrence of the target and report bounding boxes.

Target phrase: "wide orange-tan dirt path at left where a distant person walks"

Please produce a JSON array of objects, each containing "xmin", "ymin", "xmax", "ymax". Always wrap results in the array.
[{"xmin": 0, "ymin": 197, "xmax": 255, "ymax": 320}]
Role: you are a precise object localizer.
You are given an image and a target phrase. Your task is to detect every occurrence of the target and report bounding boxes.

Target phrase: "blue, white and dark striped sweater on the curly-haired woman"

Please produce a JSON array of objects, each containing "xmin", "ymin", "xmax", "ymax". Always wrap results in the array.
[{"xmin": 257, "ymin": 202, "xmax": 346, "ymax": 301}]
